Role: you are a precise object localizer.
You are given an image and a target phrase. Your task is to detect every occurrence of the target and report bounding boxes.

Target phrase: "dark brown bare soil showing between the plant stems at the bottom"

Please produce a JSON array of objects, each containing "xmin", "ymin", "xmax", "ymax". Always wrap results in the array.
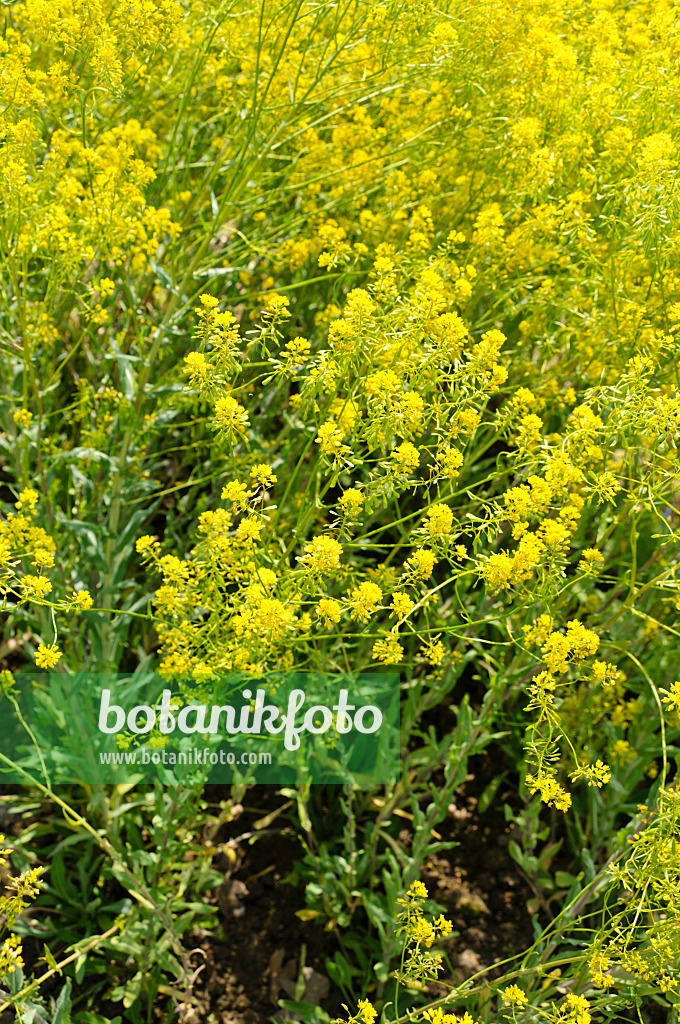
[{"xmin": 184, "ymin": 758, "xmax": 535, "ymax": 1024}]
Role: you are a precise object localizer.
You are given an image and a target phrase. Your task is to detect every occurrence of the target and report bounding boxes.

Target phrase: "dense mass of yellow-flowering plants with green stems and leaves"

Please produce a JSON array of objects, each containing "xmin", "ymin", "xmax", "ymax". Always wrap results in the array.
[{"xmin": 0, "ymin": 0, "xmax": 680, "ymax": 1024}]
